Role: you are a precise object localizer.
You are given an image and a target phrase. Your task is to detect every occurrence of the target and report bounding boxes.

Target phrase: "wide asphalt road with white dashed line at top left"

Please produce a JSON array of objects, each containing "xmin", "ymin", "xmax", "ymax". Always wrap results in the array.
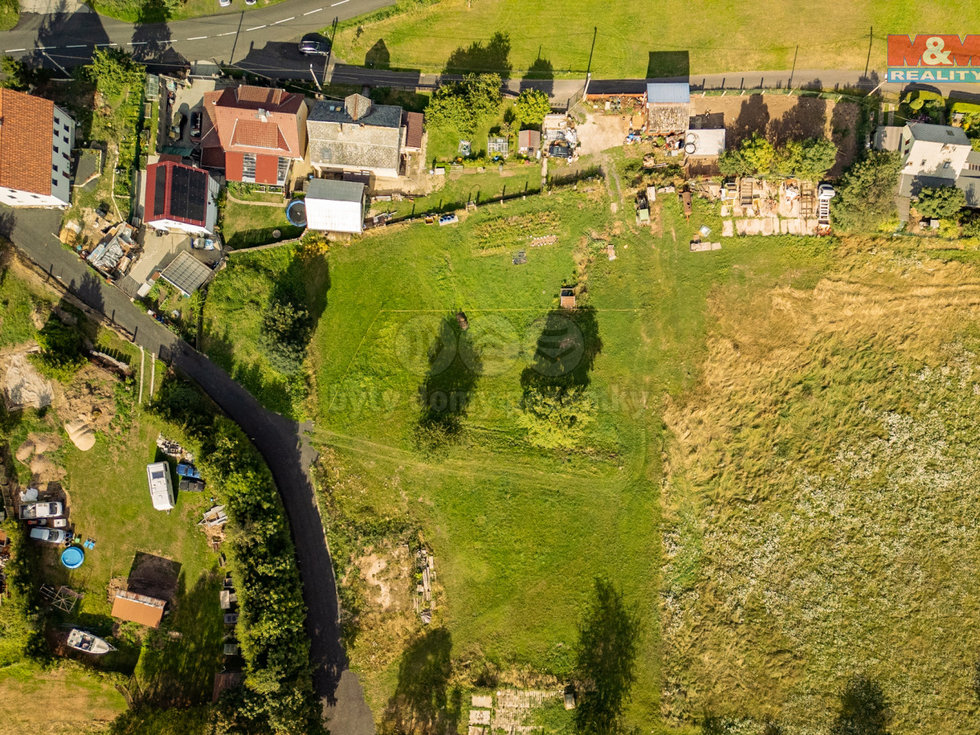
[{"xmin": 0, "ymin": 0, "xmax": 394, "ymax": 79}]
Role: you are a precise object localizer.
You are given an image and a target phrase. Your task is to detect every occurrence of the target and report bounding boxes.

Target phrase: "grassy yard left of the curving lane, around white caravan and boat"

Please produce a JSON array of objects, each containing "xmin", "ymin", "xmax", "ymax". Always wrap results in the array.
[{"xmin": 0, "ymin": 258, "xmax": 224, "ymax": 720}]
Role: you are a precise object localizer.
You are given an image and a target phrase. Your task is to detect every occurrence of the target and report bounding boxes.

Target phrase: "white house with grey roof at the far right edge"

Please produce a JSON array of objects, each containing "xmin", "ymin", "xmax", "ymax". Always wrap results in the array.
[{"xmin": 900, "ymin": 123, "xmax": 980, "ymax": 212}]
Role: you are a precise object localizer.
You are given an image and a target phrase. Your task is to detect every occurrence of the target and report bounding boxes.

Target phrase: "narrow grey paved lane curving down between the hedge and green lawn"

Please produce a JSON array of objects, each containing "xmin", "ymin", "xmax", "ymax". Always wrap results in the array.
[{"xmin": 0, "ymin": 207, "xmax": 374, "ymax": 735}]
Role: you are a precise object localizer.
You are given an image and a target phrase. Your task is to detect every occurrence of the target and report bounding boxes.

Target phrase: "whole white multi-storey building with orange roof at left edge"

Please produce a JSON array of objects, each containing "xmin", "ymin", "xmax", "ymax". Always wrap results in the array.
[{"xmin": 0, "ymin": 89, "xmax": 75, "ymax": 207}]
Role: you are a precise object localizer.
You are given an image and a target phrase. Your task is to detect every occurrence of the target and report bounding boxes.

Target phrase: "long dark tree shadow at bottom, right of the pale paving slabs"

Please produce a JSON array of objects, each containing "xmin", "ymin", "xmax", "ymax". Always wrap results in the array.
[{"xmin": 575, "ymin": 579, "xmax": 640, "ymax": 735}]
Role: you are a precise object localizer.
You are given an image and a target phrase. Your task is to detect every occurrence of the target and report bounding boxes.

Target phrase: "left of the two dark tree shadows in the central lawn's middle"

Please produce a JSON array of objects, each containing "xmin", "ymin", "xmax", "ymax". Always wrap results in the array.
[{"xmin": 417, "ymin": 312, "xmax": 483, "ymax": 445}]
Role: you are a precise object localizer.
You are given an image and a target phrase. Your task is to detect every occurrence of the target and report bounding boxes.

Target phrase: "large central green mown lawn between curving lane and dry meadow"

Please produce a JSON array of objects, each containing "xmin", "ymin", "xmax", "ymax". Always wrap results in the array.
[{"xmin": 314, "ymin": 170, "xmax": 829, "ymax": 727}]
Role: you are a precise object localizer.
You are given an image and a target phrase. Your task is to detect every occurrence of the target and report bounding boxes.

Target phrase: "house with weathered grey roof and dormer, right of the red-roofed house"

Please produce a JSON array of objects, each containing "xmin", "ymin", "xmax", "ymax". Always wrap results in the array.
[{"xmin": 306, "ymin": 94, "xmax": 405, "ymax": 177}]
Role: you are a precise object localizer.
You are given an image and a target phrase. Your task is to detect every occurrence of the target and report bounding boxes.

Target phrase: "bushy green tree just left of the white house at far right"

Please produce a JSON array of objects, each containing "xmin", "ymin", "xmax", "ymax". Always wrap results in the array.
[{"xmin": 831, "ymin": 152, "xmax": 902, "ymax": 232}]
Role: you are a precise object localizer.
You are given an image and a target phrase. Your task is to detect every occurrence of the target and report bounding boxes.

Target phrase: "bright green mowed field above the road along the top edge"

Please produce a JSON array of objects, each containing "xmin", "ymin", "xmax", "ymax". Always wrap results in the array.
[{"xmin": 335, "ymin": 0, "xmax": 980, "ymax": 79}]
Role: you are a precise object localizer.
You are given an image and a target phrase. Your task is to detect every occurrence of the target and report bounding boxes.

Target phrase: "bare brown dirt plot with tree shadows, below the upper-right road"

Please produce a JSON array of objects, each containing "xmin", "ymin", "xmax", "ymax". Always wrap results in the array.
[{"xmin": 691, "ymin": 94, "xmax": 860, "ymax": 176}]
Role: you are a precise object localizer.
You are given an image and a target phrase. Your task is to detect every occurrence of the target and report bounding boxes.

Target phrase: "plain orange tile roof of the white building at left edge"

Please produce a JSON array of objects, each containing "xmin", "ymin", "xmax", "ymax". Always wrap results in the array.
[{"xmin": 0, "ymin": 89, "xmax": 54, "ymax": 195}]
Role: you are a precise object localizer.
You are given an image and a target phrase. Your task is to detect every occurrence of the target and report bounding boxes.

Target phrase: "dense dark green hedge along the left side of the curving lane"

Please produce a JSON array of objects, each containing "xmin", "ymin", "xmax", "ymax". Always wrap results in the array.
[{"xmin": 155, "ymin": 378, "xmax": 322, "ymax": 733}]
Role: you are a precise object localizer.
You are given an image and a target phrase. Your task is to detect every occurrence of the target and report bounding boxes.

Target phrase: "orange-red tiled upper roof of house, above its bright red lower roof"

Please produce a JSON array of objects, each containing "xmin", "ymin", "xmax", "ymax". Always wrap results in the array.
[{"xmin": 201, "ymin": 85, "xmax": 305, "ymax": 158}]
